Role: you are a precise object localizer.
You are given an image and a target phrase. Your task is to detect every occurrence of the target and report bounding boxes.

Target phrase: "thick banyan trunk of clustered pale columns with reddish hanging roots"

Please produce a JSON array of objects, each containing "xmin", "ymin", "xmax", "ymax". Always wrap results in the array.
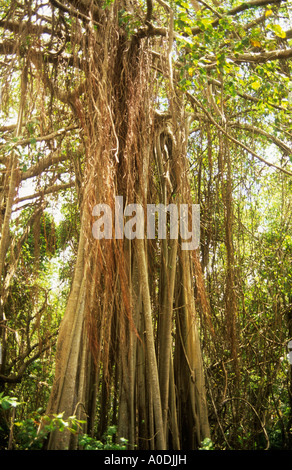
[{"xmin": 43, "ymin": 2, "xmax": 209, "ymax": 450}]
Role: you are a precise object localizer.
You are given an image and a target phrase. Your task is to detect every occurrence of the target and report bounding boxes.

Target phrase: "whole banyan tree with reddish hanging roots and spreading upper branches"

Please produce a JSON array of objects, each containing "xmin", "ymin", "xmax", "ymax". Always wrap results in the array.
[{"xmin": 0, "ymin": 0, "xmax": 291, "ymax": 450}]
